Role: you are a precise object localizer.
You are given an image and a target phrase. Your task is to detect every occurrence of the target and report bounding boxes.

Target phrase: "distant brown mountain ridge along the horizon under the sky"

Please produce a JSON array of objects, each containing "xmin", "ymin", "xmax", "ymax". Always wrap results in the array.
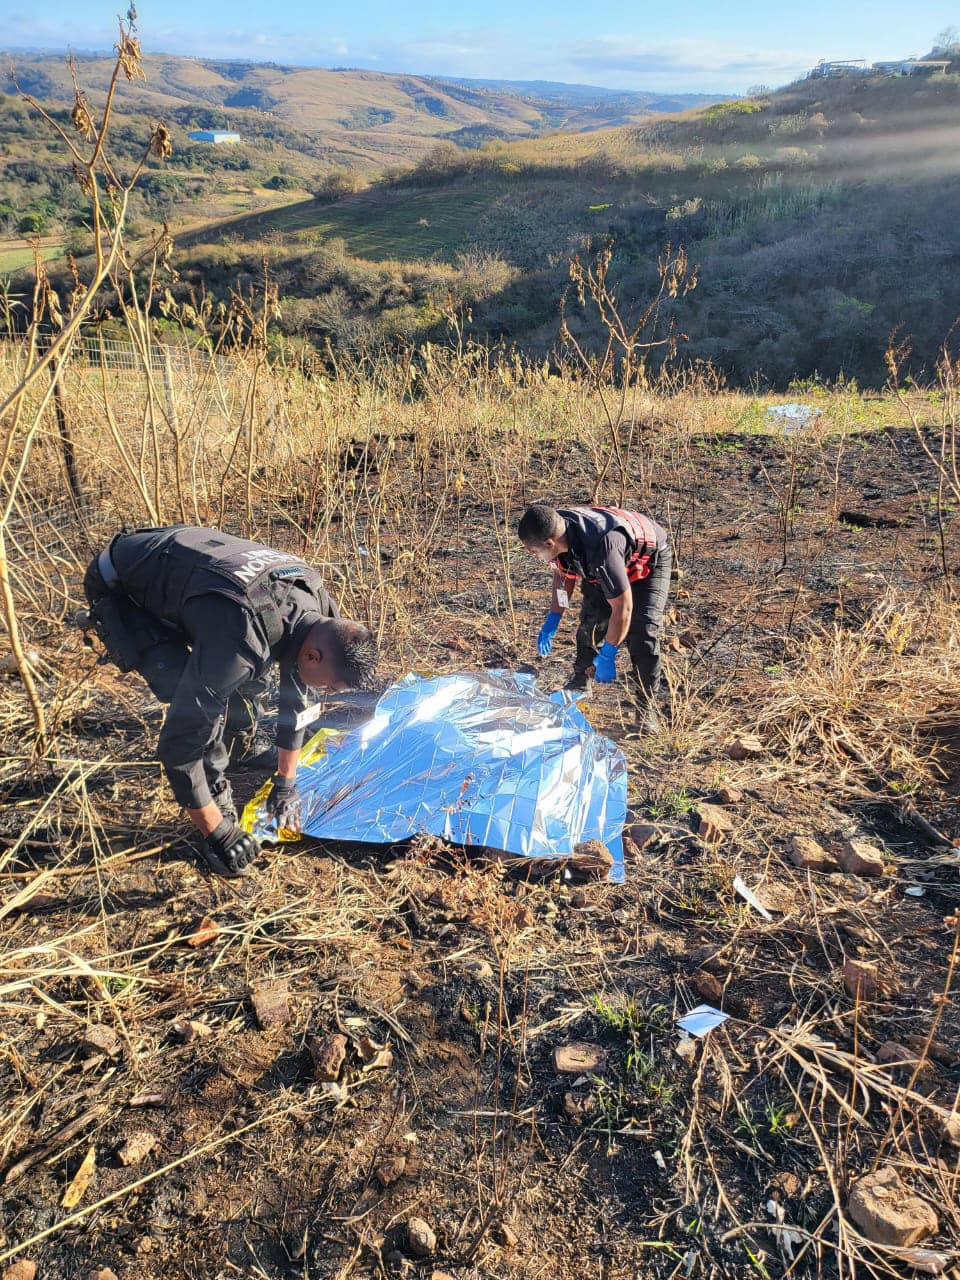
[{"xmin": 0, "ymin": 54, "xmax": 718, "ymax": 169}]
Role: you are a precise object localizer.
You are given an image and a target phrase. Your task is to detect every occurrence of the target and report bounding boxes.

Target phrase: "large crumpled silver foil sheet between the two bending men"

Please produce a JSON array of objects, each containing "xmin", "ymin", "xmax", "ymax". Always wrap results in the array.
[{"xmin": 244, "ymin": 671, "xmax": 627, "ymax": 881}]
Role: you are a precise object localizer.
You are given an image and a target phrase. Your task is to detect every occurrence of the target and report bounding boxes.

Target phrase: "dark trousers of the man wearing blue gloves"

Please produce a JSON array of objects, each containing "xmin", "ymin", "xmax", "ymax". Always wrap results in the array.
[{"xmin": 573, "ymin": 547, "xmax": 673, "ymax": 699}]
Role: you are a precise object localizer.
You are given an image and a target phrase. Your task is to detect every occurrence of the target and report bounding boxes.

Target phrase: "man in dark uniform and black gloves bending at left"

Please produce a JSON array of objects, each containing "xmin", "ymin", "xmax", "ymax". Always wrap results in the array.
[{"xmin": 83, "ymin": 525, "xmax": 378, "ymax": 876}]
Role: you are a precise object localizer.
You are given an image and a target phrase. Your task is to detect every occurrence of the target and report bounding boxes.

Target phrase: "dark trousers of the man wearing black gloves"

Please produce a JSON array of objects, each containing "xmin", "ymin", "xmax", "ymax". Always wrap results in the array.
[{"xmin": 83, "ymin": 557, "xmax": 268, "ymax": 797}]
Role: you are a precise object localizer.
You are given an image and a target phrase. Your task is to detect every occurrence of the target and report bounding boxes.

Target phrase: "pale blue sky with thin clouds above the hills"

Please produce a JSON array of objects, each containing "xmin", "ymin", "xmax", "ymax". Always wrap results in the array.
[{"xmin": 0, "ymin": 0, "xmax": 960, "ymax": 92}]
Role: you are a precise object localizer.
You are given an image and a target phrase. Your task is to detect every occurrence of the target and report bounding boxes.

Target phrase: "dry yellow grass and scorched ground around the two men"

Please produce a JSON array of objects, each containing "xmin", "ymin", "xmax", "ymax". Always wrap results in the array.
[{"xmin": 0, "ymin": 325, "xmax": 960, "ymax": 1280}]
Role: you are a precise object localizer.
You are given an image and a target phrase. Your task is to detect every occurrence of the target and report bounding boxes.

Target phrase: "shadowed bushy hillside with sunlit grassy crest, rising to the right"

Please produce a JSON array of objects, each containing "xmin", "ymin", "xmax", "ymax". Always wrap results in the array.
[{"xmin": 172, "ymin": 67, "xmax": 960, "ymax": 384}]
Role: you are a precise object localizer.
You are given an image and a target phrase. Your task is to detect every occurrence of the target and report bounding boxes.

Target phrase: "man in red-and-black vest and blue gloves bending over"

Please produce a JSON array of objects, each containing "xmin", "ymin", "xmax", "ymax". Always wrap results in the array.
[{"xmin": 517, "ymin": 503, "xmax": 673, "ymax": 731}]
